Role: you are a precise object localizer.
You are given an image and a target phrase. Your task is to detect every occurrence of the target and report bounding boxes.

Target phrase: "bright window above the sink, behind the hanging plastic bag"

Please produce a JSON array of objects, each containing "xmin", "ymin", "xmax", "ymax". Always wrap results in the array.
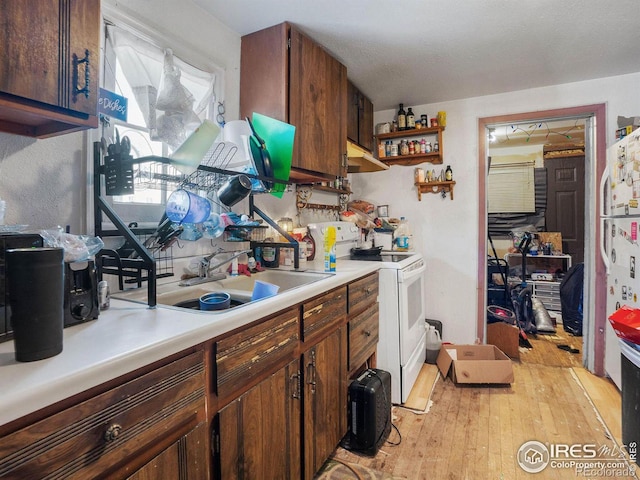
[{"xmin": 103, "ymin": 24, "xmax": 224, "ymax": 209}]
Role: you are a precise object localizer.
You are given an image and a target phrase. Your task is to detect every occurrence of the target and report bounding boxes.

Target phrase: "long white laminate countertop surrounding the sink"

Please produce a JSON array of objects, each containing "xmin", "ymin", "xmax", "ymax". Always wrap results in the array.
[{"xmin": 0, "ymin": 260, "xmax": 379, "ymax": 425}]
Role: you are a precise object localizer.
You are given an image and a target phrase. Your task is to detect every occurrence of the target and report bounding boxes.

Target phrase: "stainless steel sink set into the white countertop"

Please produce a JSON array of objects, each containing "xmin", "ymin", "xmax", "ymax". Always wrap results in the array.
[{"xmin": 113, "ymin": 270, "xmax": 333, "ymax": 313}]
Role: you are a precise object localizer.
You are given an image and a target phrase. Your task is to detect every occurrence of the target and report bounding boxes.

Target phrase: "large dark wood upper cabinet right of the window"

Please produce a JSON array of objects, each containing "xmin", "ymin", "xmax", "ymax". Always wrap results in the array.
[{"xmin": 240, "ymin": 23, "xmax": 347, "ymax": 182}]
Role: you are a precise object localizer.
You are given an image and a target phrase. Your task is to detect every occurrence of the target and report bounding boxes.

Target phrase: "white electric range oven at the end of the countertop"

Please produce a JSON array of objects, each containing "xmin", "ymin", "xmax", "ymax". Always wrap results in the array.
[{"xmin": 309, "ymin": 222, "xmax": 427, "ymax": 404}]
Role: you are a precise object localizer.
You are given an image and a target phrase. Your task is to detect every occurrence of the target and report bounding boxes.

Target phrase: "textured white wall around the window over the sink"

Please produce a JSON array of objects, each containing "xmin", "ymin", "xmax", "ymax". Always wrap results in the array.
[{"xmin": 0, "ymin": 0, "xmax": 240, "ymax": 233}]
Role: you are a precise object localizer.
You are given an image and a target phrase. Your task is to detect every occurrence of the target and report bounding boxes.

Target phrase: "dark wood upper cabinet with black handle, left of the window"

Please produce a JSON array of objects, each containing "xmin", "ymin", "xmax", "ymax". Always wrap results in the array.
[{"xmin": 0, "ymin": 0, "xmax": 100, "ymax": 138}]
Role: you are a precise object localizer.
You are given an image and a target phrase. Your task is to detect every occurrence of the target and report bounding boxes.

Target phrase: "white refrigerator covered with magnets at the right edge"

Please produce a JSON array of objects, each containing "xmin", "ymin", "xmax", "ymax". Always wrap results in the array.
[{"xmin": 600, "ymin": 129, "xmax": 640, "ymax": 389}]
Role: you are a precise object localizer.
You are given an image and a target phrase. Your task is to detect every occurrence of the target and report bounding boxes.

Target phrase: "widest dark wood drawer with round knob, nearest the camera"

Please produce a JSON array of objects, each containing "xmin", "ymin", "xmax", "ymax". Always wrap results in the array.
[{"xmin": 0, "ymin": 351, "xmax": 205, "ymax": 479}]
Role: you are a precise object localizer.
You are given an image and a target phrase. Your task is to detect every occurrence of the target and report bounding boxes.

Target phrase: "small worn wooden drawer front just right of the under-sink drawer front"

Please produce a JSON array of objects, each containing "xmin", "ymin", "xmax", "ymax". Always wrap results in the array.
[{"xmin": 302, "ymin": 287, "xmax": 347, "ymax": 342}]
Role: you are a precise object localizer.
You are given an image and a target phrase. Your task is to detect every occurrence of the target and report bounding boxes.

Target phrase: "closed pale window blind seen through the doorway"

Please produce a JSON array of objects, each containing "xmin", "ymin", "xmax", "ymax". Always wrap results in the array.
[{"xmin": 487, "ymin": 154, "xmax": 536, "ymax": 213}]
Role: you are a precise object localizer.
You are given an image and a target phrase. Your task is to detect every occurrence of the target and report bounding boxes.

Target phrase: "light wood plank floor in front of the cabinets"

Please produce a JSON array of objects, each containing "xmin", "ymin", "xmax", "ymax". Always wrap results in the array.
[{"xmin": 334, "ymin": 326, "xmax": 635, "ymax": 480}]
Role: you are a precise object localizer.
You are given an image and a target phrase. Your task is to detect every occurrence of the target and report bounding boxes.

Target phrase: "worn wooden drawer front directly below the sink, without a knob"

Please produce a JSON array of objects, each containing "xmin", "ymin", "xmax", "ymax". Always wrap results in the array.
[{"xmin": 216, "ymin": 308, "xmax": 300, "ymax": 404}]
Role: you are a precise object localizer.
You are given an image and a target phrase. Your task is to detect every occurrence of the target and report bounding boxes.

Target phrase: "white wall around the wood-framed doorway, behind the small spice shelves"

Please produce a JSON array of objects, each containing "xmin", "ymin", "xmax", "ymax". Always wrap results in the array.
[{"xmin": 352, "ymin": 73, "xmax": 640, "ymax": 343}]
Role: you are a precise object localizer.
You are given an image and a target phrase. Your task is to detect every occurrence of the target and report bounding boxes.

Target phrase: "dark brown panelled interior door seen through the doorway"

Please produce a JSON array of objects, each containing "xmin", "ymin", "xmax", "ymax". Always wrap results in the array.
[{"xmin": 544, "ymin": 156, "xmax": 585, "ymax": 265}]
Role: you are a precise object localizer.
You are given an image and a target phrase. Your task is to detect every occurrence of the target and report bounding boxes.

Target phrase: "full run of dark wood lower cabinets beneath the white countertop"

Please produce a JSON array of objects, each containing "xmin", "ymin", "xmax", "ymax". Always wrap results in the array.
[{"xmin": 0, "ymin": 274, "xmax": 378, "ymax": 480}]
